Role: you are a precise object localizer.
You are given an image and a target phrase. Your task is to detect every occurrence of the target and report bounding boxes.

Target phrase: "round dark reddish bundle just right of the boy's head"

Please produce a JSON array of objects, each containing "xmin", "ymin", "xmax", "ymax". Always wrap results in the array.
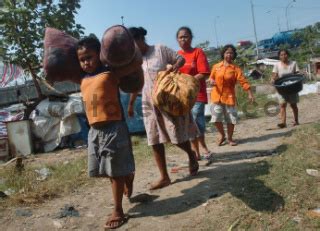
[{"xmin": 100, "ymin": 25, "xmax": 136, "ymax": 67}]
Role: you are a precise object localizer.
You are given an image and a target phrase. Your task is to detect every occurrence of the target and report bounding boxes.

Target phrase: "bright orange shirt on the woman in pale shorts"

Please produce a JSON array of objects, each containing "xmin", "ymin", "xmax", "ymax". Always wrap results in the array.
[{"xmin": 210, "ymin": 61, "xmax": 250, "ymax": 106}]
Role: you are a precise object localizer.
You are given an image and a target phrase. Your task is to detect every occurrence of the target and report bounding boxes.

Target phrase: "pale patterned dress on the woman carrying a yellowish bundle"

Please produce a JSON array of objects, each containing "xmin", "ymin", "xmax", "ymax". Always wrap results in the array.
[{"xmin": 142, "ymin": 45, "xmax": 198, "ymax": 145}]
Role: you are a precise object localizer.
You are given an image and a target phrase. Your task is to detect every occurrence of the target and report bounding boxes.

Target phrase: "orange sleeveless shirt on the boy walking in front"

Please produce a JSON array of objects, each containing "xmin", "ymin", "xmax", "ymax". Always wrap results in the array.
[{"xmin": 80, "ymin": 72, "xmax": 122, "ymax": 125}]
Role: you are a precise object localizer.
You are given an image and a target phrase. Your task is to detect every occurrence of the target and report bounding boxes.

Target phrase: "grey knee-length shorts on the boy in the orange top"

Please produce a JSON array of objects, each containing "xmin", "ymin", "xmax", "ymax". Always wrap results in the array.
[{"xmin": 88, "ymin": 121, "xmax": 135, "ymax": 177}]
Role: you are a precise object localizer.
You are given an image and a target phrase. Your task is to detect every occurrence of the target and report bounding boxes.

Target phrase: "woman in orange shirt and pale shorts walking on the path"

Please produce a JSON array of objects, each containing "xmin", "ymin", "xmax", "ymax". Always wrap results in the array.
[{"xmin": 210, "ymin": 44, "xmax": 254, "ymax": 146}]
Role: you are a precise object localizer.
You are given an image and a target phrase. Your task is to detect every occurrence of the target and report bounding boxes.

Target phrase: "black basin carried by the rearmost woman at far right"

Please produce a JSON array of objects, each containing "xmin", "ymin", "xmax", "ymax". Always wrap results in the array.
[{"xmin": 274, "ymin": 74, "xmax": 304, "ymax": 95}]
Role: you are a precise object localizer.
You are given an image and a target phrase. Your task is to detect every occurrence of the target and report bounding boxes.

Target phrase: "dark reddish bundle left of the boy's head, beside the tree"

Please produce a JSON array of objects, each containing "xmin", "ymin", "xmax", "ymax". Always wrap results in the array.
[{"xmin": 43, "ymin": 28, "xmax": 84, "ymax": 83}]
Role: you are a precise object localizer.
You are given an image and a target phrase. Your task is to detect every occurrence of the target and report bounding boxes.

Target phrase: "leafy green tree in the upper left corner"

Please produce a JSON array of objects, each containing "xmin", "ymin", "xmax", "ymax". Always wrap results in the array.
[{"xmin": 0, "ymin": 0, "xmax": 84, "ymax": 98}]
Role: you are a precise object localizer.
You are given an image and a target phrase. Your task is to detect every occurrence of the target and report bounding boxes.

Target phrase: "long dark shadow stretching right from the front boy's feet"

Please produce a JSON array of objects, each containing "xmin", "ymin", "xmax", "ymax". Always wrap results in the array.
[{"xmin": 128, "ymin": 150, "xmax": 284, "ymax": 217}]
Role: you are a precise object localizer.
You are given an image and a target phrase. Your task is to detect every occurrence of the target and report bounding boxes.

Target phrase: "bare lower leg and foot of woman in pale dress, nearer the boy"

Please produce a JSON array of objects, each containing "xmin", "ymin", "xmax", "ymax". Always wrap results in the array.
[{"xmin": 150, "ymin": 144, "xmax": 171, "ymax": 190}]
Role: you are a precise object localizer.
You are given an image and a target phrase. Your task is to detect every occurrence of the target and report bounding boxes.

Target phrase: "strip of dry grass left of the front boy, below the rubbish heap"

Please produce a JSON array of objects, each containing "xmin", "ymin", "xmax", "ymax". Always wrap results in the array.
[{"xmin": 0, "ymin": 157, "xmax": 90, "ymax": 206}]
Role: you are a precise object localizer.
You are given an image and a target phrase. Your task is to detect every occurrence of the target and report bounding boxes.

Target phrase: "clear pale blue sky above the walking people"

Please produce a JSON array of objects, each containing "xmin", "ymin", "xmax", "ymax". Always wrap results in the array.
[{"xmin": 76, "ymin": 0, "xmax": 320, "ymax": 50}]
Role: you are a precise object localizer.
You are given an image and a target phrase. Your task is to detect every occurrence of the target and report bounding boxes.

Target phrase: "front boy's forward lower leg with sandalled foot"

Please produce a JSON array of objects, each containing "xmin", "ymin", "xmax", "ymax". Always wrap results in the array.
[{"xmin": 105, "ymin": 176, "xmax": 126, "ymax": 228}]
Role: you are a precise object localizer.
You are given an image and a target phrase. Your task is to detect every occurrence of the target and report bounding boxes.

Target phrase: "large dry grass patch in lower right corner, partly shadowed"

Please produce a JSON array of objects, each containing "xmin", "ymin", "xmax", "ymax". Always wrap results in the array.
[{"xmin": 200, "ymin": 123, "xmax": 320, "ymax": 230}]
